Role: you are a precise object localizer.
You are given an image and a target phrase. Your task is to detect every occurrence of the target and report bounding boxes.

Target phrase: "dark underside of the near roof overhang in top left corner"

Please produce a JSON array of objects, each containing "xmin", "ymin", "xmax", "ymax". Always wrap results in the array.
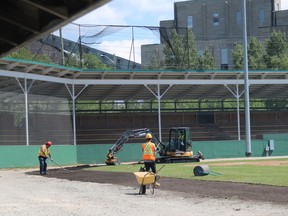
[{"xmin": 0, "ymin": 0, "xmax": 110, "ymax": 57}]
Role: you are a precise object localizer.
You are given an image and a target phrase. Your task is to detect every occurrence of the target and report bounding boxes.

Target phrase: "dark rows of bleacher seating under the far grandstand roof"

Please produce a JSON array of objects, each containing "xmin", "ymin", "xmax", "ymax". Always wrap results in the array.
[{"xmin": 0, "ymin": 112, "xmax": 288, "ymax": 145}]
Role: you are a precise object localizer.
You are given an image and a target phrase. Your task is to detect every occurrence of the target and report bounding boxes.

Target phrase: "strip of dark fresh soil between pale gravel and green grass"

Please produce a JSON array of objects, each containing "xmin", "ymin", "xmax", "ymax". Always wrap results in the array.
[{"xmin": 26, "ymin": 166, "xmax": 288, "ymax": 205}]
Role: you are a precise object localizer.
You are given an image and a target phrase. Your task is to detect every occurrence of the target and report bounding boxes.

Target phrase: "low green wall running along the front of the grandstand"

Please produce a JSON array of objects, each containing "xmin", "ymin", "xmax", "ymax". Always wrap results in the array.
[{"xmin": 0, "ymin": 134, "xmax": 288, "ymax": 168}]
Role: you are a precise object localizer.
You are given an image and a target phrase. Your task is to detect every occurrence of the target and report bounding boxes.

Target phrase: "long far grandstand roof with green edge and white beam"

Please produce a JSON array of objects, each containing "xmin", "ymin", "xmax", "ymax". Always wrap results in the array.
[{"xmin": 0, "ymin": 58, "xmax": 288, "ymax": 101}]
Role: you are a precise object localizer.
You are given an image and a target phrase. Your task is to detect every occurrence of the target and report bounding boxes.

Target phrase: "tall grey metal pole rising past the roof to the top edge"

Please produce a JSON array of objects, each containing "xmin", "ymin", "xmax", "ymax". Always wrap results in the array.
[{"xmin": 243, "ymin": 0, "xmax": 252, "ymax": 157}]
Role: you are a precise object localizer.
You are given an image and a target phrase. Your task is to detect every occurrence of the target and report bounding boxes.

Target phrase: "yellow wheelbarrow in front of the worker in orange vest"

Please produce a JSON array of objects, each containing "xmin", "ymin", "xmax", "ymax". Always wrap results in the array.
[{"xmin": 134, "ymin": 166, "xmax": 164, "ymax": 194}]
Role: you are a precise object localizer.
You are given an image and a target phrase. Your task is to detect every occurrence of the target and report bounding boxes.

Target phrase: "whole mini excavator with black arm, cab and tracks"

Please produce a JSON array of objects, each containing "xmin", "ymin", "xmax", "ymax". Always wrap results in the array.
[{"xmin": 106, "ymin": 127, "xmax": 204, "ymax": 165}]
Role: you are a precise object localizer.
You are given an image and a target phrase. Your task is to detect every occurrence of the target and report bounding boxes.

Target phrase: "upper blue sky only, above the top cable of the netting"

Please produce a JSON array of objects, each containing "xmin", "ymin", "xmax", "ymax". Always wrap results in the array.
[{"xmin": 75, "ymin": 0, "xmax": 288, "ymax": 26}]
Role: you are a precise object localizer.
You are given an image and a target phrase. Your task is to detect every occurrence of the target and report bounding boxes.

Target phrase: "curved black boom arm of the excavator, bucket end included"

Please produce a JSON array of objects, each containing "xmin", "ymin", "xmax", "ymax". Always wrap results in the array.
[{"xmin": 106, "ymin": 128, "xmax": 164, "ymax": 165}]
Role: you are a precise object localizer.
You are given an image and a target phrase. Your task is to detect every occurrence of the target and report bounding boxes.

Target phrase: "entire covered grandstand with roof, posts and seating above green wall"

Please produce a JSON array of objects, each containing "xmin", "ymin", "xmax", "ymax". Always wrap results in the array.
[{"xmin": 0, "ymin": 58, "xmax": 288, "ymax": 145}]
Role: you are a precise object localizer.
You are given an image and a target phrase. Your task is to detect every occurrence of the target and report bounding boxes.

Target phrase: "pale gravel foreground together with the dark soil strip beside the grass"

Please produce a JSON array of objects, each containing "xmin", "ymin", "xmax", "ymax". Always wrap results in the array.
[{"xmin": 0, "ymin": 167, "xmax": 288, "ymax": 216}]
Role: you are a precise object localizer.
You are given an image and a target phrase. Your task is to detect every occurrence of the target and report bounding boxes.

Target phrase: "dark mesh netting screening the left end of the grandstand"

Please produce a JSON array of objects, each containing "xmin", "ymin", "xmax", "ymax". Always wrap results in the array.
[{"xmin": 0, "ymin": 78, "xmax": 73, "ymax": 145}]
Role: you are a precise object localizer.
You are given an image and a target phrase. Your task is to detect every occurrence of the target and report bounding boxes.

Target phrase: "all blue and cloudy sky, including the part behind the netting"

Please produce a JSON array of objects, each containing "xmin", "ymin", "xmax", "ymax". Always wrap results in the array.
[{"xmin": 64, "ymin": 0, "xmax": 288, "ymax": 63}]
